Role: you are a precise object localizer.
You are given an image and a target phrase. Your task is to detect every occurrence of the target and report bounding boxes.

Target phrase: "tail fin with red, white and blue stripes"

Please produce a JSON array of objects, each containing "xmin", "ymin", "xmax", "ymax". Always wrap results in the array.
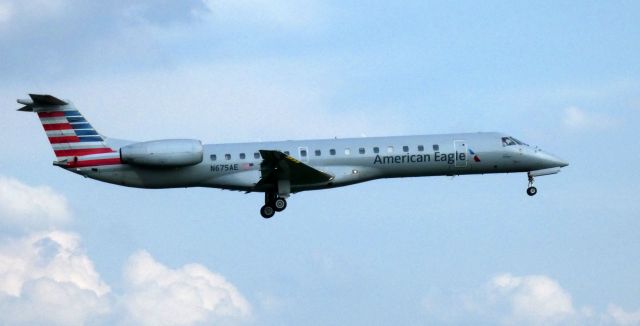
[{"xmin": 18, "ymin": 94, "xmax": 115, "ymax": 166}]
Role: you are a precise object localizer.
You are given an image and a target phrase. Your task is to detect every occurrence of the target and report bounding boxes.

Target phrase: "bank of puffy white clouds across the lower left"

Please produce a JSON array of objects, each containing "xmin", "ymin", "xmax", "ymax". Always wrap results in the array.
[{"xmin": 0, "ymin": 177, "xmax": 251, "ymax": 325}]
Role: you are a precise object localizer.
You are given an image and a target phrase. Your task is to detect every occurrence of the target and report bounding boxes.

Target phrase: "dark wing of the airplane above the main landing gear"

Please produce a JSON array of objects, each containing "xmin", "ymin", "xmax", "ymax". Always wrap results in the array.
[{"xmin": 257, "ymin": 150, "xmax": 333, "ymax": 186}]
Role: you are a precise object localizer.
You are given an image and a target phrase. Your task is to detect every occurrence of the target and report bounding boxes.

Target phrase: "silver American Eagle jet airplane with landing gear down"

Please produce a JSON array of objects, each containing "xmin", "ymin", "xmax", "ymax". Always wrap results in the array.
[{"xmin": 17, "ymin": 94, "xmax": 568, "ymax": 218}]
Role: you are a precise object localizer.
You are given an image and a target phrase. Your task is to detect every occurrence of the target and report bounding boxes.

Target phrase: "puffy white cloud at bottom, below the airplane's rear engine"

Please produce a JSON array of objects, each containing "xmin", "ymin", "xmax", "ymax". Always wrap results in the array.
[{"xmin": 124, "ymin": 251, "xmax": 250, "ymax": 325}]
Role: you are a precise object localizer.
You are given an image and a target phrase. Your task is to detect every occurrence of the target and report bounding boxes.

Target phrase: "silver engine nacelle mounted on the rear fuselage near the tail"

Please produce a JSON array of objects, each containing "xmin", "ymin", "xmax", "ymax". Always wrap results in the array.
[{"xmin": 120, "ymin": 139, "xmax": 203, "ymax": 168}]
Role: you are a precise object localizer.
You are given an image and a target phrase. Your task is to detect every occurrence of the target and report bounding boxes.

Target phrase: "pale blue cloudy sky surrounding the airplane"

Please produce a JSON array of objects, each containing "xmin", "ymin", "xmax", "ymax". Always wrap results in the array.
[{"xmin": 0, "ymin": 0, "xmax": 640, "ymax": 325}]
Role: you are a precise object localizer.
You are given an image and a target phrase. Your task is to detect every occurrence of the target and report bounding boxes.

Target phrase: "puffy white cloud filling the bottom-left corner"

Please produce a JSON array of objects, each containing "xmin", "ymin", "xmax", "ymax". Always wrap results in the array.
[{"xmin": 0, "ymin": 231, "xmax": 110, "ymax": 325}]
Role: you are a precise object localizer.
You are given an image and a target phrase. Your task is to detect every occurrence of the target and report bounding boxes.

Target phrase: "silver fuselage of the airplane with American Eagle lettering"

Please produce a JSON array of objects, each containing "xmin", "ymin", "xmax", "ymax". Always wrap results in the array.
[{"xmin": 74, "ymin": 132, "xmax": 567, "ymax": 192}]
